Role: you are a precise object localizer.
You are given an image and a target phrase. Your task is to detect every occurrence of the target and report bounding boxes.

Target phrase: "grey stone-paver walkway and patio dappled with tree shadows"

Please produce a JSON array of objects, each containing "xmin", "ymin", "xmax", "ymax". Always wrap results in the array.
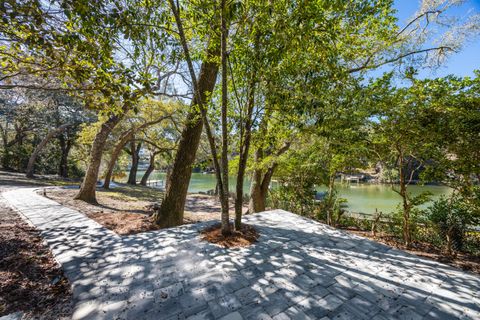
[{"xmin": 3, "ymin": 189, "xmax": 480, "ymax": 320}]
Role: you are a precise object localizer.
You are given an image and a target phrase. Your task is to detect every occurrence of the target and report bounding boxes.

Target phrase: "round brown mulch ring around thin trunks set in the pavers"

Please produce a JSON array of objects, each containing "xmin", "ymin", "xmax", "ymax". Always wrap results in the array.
[{"xmin": 201, "ymin": 223, "xmax": 260, "ymax": 248}]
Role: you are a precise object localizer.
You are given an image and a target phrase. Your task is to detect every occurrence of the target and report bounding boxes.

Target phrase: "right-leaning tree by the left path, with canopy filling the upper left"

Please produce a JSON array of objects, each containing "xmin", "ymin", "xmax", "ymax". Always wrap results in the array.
[{"xmin": 0, "ymin": 0, "xmax": 172, "ymax": 202}]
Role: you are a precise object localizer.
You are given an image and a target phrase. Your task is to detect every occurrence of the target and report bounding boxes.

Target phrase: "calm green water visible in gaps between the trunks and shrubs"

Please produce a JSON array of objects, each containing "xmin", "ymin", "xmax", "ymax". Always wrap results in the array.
[{"xmin": 131, "ymin": 171, "xmax": 449, "ymax": 213}]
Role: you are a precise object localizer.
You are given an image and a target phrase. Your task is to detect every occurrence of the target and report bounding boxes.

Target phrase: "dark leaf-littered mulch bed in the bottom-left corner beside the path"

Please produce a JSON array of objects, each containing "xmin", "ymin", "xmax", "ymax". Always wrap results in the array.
[{"xmin": 0, "ymin": 202, "xmax": 72, "ymax": 319}]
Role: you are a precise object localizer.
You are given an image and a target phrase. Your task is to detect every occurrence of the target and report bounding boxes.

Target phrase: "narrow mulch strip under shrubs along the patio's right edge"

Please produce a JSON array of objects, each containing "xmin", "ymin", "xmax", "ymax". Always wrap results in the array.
[{"xmin": 344, "ymin": 229, "xmax": 480, "ymax": 274}]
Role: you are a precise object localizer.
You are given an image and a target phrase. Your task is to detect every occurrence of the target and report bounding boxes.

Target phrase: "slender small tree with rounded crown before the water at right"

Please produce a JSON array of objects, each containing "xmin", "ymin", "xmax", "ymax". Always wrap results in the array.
[{"xmin": 372, "ymin": 73, "xmax": 444, "ymax": 246}]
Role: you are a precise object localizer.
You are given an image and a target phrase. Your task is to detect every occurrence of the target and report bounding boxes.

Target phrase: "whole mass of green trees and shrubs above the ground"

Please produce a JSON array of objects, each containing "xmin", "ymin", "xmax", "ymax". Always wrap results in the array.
[{"xmin": 0, "ymin": 0, "xmax": 480, "ymax": 264}]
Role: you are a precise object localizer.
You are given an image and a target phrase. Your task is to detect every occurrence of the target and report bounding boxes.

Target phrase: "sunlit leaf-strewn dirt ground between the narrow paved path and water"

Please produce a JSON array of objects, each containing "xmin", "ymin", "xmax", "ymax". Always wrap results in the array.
[{"xmin": 43, "ymin": 185, "xmax": 246, "ymax": 235}]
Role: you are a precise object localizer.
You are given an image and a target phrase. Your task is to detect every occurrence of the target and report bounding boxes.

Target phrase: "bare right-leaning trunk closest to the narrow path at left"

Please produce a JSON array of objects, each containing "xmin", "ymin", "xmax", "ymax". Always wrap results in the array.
[{"xmin": 75, "ymin": 110, "xmax": 126, "ymax": 203}]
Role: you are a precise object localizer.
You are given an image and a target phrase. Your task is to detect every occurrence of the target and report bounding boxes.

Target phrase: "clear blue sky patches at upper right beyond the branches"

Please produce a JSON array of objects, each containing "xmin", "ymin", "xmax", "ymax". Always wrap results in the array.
[{"xmin": 395, "ymin": 0, "xmax": 480, "ymax": 78}]
